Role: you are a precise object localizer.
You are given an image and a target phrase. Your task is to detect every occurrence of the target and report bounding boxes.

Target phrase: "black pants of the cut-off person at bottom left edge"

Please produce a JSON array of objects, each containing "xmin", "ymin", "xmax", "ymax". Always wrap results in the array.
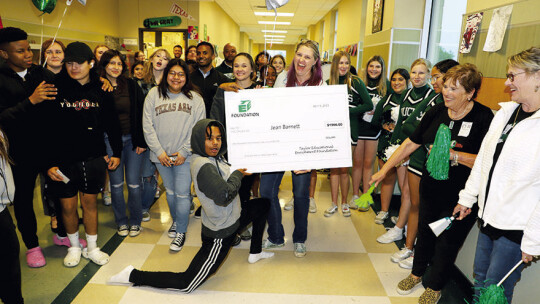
[{"xmin": 0, "ymin": 208, "xmax": 24, "ymax": 304}]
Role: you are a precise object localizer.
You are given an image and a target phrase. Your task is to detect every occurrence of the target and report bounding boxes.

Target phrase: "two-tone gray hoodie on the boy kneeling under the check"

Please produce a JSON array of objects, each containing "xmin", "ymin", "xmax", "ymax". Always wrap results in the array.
[{"xmin": 191, "ymin": 119, "xmax": 243, "ymax": 238}]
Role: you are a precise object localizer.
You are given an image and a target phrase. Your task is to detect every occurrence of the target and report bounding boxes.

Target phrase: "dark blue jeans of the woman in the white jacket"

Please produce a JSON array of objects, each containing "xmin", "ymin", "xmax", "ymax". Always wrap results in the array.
[{"xmin": 474, "ymin": 231, "xmax": 524, "ymax": 303}]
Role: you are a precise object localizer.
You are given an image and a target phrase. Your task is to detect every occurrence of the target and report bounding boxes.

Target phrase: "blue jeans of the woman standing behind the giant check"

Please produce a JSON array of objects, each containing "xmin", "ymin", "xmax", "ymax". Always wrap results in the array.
[{"xmin": 260, "ymin": 172, "xmax": 310, "ymax": 244}]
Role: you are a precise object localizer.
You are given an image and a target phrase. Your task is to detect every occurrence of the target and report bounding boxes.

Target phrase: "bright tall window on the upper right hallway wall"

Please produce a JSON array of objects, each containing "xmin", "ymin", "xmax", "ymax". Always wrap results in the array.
[{"xmin": 422, "ymin": 0, "xmax": 467, "ymax": 64}]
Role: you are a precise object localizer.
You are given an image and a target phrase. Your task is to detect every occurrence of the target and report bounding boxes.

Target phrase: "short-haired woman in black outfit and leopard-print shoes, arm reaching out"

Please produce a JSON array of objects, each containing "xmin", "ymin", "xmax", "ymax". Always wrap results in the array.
[{"xmin": 370, "ymin": 64, "xmax": 493, "ymax": 303}]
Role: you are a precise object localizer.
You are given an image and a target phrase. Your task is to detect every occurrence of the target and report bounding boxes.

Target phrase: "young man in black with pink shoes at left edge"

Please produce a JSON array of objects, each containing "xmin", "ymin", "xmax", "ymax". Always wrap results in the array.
[{"xmin": 0, "ymin": 27, "xmax": 56, "ymax": 267}]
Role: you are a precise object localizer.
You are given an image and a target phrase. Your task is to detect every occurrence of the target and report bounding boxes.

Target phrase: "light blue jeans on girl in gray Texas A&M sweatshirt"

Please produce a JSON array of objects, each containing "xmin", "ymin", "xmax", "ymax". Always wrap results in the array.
[{"xmin": 156, "ymin": 162, "xmax": 191, "ymax": 233}]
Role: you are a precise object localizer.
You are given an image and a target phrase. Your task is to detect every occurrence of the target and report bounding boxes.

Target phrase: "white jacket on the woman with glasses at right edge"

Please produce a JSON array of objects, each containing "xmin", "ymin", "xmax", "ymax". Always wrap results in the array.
[{"xmin": 458, "ymin": 102, "xmax": 540, "ymax": 255}]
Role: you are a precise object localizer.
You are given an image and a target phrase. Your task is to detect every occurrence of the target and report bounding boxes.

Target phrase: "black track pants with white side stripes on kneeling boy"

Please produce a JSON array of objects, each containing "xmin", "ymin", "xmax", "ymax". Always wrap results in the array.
[{"xmin": 129, "ymin": 198, "xmax": 270, "ymax": 293}]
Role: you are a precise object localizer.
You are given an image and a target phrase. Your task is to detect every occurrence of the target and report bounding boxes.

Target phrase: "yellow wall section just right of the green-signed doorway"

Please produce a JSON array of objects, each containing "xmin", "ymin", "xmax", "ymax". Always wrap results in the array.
[{"xmin": 198, "ymin": 2, "xmax": 240, "ymax": 50}]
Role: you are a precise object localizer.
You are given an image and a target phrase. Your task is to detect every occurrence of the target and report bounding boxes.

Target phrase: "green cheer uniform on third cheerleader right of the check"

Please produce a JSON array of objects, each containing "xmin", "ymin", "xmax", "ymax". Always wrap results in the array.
[{"xmin": 371, "ymin": 92, "xmax": 403, "ymax": 162}]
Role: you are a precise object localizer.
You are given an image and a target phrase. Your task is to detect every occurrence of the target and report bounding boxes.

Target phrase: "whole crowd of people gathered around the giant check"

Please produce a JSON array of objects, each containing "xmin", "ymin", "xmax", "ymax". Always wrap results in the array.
[{"xmin": 0, "ymin": 28, "xmax": 540, "ymax": 303}]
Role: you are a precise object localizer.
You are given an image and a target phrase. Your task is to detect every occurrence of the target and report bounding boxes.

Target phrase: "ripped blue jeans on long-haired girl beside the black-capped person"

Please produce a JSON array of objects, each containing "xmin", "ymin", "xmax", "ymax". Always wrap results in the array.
[{"xmin": 105, "ymin": 134, "xmax": 143, "ymax": 226}]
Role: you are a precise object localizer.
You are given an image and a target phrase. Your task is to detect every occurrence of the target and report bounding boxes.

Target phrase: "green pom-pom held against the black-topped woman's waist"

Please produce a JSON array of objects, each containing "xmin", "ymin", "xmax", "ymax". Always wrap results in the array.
[{"xmin": 426, "ymin": 124, "xmax": 452, "ymax": 180}]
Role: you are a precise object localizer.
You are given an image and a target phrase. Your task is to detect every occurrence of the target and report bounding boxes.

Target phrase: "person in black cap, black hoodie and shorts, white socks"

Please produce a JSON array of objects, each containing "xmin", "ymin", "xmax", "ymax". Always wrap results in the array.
[{"xmin": 45, "ymin": 42, "xmax": 122, "ymax": 267}]
